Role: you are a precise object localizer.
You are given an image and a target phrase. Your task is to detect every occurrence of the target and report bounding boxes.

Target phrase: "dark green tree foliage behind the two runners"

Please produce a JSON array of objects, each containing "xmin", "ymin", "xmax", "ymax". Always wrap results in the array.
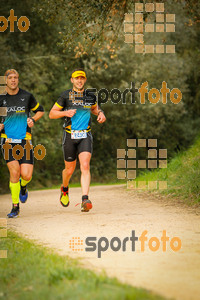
[{"xmin": 0, "ymin": 0, "xmax": 200, "ymax": 193}]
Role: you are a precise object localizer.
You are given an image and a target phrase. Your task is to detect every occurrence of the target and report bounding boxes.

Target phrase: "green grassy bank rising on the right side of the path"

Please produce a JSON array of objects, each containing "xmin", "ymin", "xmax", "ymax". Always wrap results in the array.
[{"xmin": 131, "ymin": 136, "xmax": 200, "ymax": 205}]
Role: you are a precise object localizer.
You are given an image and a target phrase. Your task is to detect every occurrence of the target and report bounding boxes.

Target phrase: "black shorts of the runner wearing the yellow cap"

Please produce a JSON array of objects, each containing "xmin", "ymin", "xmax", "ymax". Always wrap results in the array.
[{"xmin": 63, "ymin": 131, "xmax": 93, "ymax": 162}]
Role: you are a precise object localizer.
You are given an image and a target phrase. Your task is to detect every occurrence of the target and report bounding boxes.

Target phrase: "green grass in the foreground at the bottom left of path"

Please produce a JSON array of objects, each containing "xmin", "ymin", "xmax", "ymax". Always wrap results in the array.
[{"xmin": 0, "ymin": 231, "xmax": 164, "ymax": 300}]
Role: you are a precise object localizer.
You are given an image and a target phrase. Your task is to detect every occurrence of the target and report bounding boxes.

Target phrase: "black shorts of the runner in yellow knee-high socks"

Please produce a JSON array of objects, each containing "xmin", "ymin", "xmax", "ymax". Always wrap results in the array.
[{"xmin": 1, "ymin": 138, "xmax": 34, "ymax": 165}]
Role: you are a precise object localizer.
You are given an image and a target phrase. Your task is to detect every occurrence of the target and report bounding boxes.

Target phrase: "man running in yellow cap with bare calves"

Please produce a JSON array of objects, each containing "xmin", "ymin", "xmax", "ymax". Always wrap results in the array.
[{"xmin": 49, "ymin": 68, "xmax": 106, "ymax": 212}]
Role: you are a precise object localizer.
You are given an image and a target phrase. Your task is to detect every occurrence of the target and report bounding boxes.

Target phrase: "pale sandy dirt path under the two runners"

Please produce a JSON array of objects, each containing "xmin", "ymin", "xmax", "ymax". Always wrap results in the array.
[{"xmin": 0, "ymin": 186, "xmax": 200, "ymax": 300}]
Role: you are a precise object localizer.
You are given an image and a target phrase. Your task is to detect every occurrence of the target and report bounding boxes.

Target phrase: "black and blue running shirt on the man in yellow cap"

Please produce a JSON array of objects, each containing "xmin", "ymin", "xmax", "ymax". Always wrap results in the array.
[{"xmin": 55, "ymin": 89, "xmax": 97, "ymax": 133}]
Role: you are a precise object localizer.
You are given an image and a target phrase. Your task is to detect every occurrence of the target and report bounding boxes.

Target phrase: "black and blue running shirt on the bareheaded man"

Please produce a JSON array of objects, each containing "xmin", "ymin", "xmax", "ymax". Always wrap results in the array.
[{"xmin": 0, "ymin": 89, "xmax": 44, "ymax": 139}]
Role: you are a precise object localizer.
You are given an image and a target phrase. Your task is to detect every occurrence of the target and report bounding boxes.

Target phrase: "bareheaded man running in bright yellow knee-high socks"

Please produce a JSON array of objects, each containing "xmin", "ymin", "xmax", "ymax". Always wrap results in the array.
[{"xmin": 0, "ymin": 69, "xmax": 44, "ymax": 218}]
